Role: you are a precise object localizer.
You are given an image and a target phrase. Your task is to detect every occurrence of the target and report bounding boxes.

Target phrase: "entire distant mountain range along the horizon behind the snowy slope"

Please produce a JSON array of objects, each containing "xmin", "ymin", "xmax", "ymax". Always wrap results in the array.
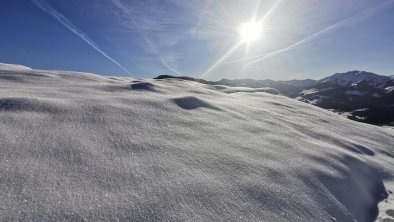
[{"xmin": 156, "ymin": 70, "xmax": 394, "ymax": 125}]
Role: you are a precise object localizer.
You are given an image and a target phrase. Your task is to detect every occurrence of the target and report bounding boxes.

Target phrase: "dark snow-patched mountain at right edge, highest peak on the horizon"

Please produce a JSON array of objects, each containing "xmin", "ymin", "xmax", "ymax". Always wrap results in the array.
[{"xmin": 293, "ymin": 71, "xmax": 394, "ymax": 125}]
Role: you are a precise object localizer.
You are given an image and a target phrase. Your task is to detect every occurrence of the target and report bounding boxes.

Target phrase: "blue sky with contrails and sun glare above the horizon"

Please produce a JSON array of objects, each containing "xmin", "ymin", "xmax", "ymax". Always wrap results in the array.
[{"xmin": 0, "ymin": 0, "xmax": 394, "ymax": 80}]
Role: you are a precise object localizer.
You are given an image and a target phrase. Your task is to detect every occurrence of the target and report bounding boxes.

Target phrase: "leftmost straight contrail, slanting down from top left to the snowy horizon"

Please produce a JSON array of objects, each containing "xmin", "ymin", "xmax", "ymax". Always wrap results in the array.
[{"xmin": 31, "ymin": 0, "xmax": 131, "ymax": 75}]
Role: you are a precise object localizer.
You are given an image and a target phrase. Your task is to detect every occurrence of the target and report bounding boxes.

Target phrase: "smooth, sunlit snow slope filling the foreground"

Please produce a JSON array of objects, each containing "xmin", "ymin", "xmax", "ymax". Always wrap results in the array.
[{"xmin": 0, "ymin": 70, "xmax": 394, "ymax": 221}]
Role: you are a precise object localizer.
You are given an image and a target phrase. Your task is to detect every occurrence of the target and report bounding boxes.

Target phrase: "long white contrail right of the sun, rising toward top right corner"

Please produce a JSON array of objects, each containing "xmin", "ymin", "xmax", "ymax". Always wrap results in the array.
[{"xmin": 225, "ymin": 0, "xmax": 394, "ymax": 66}]
